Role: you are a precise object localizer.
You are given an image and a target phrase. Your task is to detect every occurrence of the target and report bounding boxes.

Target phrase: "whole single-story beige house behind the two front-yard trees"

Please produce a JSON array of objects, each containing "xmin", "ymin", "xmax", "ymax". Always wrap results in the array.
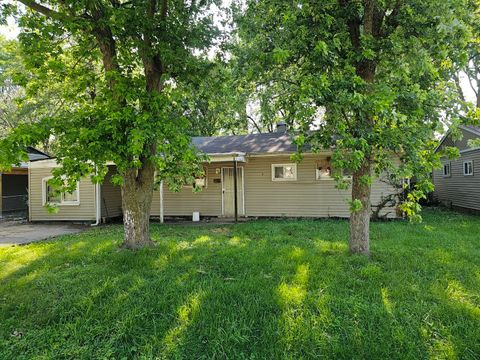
[{"xmin": 29, "ymin": 127, "xmax": 398, "ymax": 221}]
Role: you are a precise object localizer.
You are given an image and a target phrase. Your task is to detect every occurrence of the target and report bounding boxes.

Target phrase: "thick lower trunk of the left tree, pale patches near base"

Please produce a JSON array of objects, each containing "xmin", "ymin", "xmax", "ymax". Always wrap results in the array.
[{"xmin": 122, "ymin": 159, "xmax": 155, "ymax": 249}]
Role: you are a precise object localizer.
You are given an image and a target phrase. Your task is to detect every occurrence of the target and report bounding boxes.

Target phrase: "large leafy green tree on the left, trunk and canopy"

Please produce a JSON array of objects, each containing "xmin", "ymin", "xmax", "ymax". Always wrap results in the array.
[{"xmin": 0, "ymin": 0, "xmax": 221, "ymax": 248}]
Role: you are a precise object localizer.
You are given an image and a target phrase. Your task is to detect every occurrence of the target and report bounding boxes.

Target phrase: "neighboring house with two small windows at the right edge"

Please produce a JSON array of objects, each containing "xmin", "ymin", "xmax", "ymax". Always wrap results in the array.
[{"xmin": 433, "ymin": 126, "xmax": 480, "ymax": 211}]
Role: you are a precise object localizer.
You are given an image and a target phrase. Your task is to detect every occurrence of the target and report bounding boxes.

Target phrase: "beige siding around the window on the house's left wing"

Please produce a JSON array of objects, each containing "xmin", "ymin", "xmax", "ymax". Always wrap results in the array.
[{"xmin": 29, "ymin": 167, "xmax": 95, "ymax": 221}]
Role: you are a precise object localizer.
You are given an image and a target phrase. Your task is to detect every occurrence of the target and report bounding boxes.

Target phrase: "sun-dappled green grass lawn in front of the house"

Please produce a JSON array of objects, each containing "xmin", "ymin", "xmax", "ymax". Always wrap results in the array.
[{"xmin": 0, "ymin": 210, "xmax": 480, "ymax": 359}]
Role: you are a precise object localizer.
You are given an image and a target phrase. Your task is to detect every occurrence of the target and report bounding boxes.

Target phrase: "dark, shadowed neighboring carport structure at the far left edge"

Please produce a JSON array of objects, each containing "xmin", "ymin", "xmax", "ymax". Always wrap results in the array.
[{"xmin": 0, "ymin": 147, "xmax": 50, "ymax": 218}]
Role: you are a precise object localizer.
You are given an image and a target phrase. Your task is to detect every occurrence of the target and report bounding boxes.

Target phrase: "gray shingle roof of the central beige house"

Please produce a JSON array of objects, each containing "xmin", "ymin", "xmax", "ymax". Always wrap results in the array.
[{"xmin": 192, "ymin": 132, "xmax": 308, "ymax": 154}]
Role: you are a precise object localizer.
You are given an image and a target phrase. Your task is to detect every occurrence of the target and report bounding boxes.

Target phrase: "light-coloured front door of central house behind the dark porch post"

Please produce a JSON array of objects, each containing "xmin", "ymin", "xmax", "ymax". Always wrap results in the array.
[{"xmin": 222, "ymin": 167, "xmax": 245, "ymax": 217}]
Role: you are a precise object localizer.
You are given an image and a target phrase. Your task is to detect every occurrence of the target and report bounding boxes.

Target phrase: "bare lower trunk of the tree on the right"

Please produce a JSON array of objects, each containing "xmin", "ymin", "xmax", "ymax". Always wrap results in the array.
[{"xmin": 349, "ymin": 159, "xmax": 371, "ymax": 255}]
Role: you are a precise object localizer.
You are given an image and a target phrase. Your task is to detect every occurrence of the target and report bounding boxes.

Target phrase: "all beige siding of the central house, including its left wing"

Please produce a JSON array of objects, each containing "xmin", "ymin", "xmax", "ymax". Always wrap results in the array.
[{"xmin": 30, "ymin": 154, "xmax": 396, "ymax": 221}]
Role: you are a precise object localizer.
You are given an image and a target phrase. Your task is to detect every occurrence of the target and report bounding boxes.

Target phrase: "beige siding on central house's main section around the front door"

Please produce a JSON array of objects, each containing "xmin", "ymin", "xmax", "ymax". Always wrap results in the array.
[{"xmin": 156, "ymin": 155, "xmax": 396, "ymax": 217}]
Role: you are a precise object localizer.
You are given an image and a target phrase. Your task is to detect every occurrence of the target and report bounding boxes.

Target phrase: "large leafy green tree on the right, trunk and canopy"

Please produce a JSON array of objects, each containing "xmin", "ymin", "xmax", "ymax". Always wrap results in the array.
[{"xmin": 234, "ymin": 0, "xmax": 469, "ymax": 254}]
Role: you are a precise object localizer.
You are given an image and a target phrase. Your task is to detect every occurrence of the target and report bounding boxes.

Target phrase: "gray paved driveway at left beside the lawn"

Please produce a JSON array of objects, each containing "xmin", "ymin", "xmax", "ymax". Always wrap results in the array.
[{"xmin": 0, "ymin": 222, "xmax": 88, "ymax": 246}]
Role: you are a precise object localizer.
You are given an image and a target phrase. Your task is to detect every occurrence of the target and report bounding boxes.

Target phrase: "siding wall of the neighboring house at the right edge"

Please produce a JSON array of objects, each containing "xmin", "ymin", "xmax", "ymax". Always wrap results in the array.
[{"xmin": 433, "ymin": 149, "xmax": 480, "ymax": 210}]
